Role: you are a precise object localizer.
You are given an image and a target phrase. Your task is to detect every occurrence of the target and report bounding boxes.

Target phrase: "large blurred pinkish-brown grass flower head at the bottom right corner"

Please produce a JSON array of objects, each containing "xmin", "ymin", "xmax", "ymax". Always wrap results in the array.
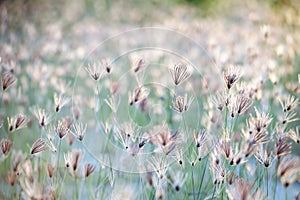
[{"xmin": 277, "ymin": 155, "xmax": 300, "ymax": 187}]
